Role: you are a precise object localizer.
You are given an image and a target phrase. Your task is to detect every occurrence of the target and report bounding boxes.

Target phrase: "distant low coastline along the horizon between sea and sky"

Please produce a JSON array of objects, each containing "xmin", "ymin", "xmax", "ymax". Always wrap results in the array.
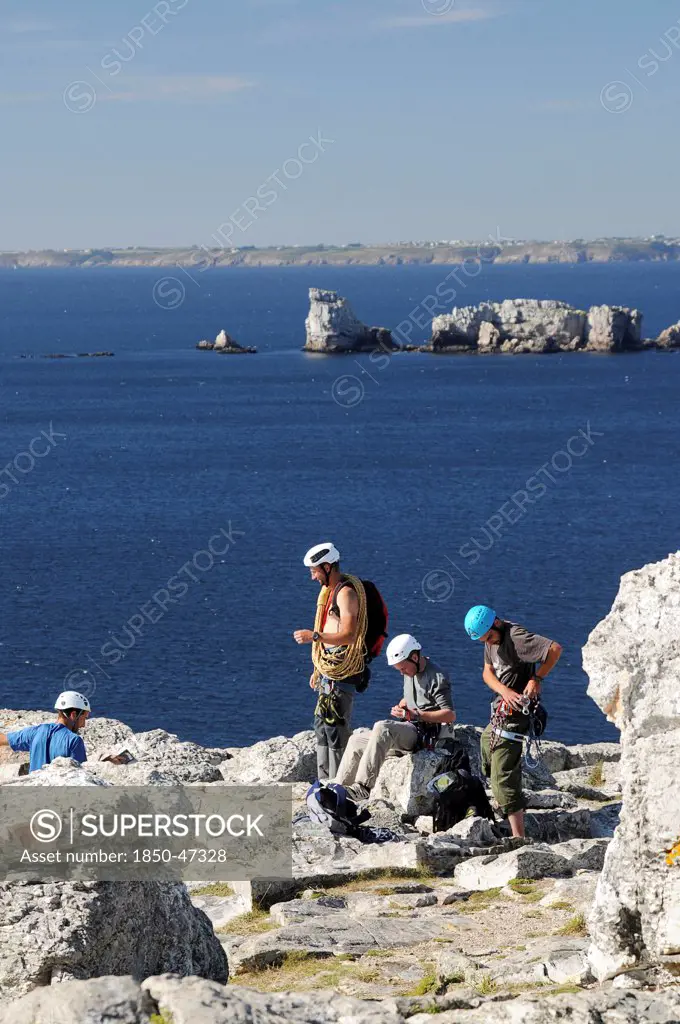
[{"xmin": 0, "ymin": 237, "xmax": 680, "ymax": 269}]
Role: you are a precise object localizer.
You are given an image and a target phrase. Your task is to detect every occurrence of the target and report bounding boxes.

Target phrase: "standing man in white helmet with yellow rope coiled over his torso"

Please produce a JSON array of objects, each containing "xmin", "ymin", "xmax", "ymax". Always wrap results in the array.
[{"xmin": 293, "ymin": 542, "xmax": 366, "ymax": 779}]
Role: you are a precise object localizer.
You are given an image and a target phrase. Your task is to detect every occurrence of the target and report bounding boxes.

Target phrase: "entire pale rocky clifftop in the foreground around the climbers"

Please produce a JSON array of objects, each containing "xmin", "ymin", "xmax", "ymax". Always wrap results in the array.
[{"xmin": 0, "ymin": 553, "xmax": 680, "ymax": 1024}]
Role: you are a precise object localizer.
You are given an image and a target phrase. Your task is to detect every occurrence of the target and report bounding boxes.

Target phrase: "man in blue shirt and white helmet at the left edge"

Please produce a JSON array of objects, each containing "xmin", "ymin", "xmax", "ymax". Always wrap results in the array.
[{"xmin": 0, "ymin": 690, "xmax": 91, "ymax": 771}]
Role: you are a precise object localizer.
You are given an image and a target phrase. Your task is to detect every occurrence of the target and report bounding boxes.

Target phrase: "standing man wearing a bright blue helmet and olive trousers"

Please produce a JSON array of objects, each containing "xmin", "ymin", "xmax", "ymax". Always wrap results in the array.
[{"xmin": 465, "ymin": 604, "xmax": 562, "ymax": 836}]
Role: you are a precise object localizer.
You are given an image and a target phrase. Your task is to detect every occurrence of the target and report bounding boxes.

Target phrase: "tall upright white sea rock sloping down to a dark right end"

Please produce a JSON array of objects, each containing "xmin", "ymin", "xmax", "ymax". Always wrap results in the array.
[{"xmin": 304, "ymin": 288, "xmax": 398, "ymax": 354}]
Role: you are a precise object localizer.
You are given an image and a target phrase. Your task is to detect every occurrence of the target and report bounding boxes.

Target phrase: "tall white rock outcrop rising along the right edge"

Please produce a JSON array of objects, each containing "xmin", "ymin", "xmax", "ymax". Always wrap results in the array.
[{"xmin": 583, "ymin": 553, "xmax": 680, "ymax": 980}]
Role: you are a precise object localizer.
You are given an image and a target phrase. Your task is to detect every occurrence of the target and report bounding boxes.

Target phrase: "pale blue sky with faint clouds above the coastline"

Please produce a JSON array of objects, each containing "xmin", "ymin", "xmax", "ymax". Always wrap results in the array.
[{"xmin": 0, "ymin": 0, "xmax": 680, "ymax": 249}]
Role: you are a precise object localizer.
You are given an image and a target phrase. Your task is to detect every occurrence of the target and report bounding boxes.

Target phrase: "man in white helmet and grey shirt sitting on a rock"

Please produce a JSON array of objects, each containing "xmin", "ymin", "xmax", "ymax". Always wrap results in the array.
[{"xmin": 335, "ymin": 633, "xmax": 456, "ymax": 802}]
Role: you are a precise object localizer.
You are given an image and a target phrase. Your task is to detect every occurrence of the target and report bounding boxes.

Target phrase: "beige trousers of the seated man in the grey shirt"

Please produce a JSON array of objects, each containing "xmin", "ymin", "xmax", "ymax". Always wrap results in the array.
[{"xmin": 335, "ymin": 719, "xmax": 418, "ymax": 800}]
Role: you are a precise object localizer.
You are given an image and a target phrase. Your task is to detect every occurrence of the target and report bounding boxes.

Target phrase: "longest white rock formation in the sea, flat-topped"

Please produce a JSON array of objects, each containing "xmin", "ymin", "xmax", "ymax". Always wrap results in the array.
[{"xmin": 429, "ymin": 299, "xmax": 642, "ymax": 353}]
